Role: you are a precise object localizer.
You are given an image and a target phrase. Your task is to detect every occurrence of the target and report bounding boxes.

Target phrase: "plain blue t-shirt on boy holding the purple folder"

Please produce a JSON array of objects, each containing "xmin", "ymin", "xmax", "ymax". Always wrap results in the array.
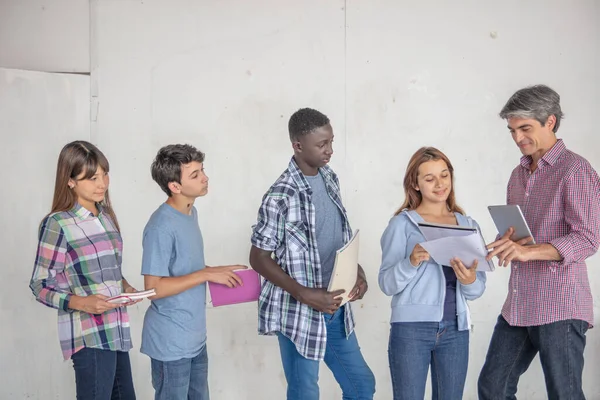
[{"xmin": 140, "ymin": 203, "xmax": 206, "ymax": 361}]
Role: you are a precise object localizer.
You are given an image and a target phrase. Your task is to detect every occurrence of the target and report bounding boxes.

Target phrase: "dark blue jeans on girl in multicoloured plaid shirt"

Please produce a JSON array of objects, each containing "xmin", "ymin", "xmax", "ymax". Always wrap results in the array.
[{"xmin": 71, "ymin": 347, "xmax": 135, "ymax": 400}]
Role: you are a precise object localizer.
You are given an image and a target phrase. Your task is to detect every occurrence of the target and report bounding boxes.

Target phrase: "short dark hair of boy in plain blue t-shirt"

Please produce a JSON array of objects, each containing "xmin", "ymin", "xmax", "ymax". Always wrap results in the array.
[{"xmin": 150, "ymin": 144, "xmax": 204, "ymax": 197}]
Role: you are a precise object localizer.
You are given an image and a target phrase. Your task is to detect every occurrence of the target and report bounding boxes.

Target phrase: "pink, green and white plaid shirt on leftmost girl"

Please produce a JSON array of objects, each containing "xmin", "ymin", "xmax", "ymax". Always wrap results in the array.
[{"xmin": 29, "ymin": 204, "xmax": 131, "ymax": 360}]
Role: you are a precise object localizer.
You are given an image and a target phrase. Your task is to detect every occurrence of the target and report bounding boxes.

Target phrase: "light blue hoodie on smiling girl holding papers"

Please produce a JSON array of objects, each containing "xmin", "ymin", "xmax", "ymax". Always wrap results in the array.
[{"xmin": 379, "ymin": 210, "xmax": 486, "ymax": 331}]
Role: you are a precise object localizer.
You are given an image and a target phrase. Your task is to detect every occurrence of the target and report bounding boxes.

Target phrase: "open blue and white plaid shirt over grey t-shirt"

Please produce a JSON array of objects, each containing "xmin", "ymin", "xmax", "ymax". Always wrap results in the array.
[{"xmin": 251, "ymin": 158, "xmax": 354, "ymax": 360}]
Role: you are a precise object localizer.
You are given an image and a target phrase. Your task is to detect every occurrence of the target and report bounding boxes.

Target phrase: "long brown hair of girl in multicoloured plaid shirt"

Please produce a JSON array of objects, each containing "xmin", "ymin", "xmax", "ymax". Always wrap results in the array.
[{"xmin": 48, "ymin": 140, "xmax": 120, "ymax": 231}]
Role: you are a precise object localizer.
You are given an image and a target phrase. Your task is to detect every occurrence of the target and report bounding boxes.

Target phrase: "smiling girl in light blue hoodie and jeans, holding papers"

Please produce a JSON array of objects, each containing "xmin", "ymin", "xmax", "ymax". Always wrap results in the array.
[{"xmin": 379, "ymin": 147, "xmax": 486, "ymax": 400}]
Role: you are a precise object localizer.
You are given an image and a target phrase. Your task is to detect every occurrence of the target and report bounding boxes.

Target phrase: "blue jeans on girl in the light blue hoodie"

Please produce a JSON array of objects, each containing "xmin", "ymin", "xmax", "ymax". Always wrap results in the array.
[{"xmin": 388, "ymin": 321, "xmax": 469, "ymax": 400}]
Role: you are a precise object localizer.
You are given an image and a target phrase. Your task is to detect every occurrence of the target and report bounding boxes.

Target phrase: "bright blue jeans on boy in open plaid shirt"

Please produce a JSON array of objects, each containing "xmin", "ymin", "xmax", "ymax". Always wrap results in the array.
[{"xmin": 277, "ymin": 307, "xmax": 375, "ymax": 400}]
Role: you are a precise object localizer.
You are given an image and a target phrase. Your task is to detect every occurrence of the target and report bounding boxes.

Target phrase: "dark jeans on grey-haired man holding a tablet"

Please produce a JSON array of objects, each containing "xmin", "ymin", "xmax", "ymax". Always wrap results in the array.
[{"xmin": 478, "ymin": 315, "xmax": 589, "ymax": 400}]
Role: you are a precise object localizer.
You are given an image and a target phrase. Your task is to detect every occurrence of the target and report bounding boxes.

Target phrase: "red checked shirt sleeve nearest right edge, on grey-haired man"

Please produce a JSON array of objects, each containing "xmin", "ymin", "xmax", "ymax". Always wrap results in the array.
[{"xmin": 550, "ymin": 165, "xmax": 600, "ymax": 264}]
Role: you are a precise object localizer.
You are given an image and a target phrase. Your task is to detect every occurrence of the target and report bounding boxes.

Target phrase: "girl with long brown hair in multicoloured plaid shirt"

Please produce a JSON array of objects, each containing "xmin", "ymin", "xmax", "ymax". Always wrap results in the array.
[{"xmin": 30, "ymin": 141, "xmax": 135, "ymax": 400}]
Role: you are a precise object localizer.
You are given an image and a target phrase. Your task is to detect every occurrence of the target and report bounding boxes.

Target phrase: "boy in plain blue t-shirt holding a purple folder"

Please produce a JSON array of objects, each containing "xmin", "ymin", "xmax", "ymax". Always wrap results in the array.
[{"xmin": 141, "ymin": 144, "xmax": 246, "ymax": 400}]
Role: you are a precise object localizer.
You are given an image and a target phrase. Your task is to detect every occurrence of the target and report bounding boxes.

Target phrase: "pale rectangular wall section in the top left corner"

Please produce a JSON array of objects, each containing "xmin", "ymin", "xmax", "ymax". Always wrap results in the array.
[{"xmin": 0, "ymin": 0, "xmax": 90, "ymax": 73}]
